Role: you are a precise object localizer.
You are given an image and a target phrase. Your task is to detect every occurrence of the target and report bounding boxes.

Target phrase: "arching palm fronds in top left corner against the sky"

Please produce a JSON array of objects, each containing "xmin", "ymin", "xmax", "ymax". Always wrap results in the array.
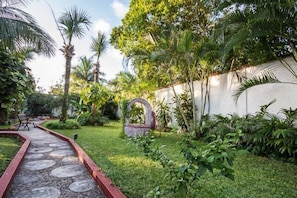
[{"xmin": 0, "ymin": 0, "xmax": 55, "ymax": 56}]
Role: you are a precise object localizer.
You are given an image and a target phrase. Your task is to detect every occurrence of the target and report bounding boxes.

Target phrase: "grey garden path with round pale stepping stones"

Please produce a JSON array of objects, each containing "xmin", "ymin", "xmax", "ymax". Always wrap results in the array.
[{"xmin": 6, "ymin": 122, "xmax": 105, "ymax": 198}]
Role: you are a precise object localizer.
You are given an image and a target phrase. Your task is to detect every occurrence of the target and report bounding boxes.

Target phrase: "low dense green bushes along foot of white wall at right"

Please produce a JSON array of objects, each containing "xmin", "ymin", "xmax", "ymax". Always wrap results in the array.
[{"xmin": 202, "ymin": 103, "xmax": 297, "ymax": 161}]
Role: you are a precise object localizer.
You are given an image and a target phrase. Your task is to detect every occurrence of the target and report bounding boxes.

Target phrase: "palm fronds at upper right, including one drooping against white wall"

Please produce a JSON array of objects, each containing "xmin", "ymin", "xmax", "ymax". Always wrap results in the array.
[{"xmin": 215, "ymin": 0, "xmax": 297, "ymax": 100}]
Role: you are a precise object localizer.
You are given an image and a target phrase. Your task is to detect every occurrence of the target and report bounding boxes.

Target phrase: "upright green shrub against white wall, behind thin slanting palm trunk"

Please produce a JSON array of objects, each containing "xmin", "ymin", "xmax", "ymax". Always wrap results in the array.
[{"xmin": 173, "ymin": 91, "xmax": 193, "ymax": 131}]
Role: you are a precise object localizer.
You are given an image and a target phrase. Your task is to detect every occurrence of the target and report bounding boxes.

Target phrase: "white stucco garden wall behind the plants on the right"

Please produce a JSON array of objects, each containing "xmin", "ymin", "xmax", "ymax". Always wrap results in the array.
[{"xmin": 155, "ymin": 55, "xmax": 297, "ymax": 120}]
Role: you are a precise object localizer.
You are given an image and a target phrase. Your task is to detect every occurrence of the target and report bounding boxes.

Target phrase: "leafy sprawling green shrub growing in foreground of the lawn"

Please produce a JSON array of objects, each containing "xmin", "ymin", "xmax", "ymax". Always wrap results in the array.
[{"xmin": 131, "ymin": 131, "xmax": 242, "ymax": 198}]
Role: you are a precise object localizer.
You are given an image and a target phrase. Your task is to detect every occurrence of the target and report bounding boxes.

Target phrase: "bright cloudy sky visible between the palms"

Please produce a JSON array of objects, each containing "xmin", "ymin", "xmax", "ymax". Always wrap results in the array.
[{"xmin": 22, "ymin": 0, "xmax": 130, "ymax": 92}]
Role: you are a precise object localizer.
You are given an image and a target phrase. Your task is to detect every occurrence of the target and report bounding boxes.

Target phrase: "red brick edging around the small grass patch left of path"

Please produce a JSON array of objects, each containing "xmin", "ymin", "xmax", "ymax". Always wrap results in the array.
[{"xmin": 0, "ymin": 131, "xmax": 31, "ymax": 197}]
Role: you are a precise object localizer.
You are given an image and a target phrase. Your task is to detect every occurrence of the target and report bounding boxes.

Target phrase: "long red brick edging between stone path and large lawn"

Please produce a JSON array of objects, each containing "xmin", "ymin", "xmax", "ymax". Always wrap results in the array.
[{"xmin": 36, "ymin": 125, "xmax": 126, "ymax": 198}]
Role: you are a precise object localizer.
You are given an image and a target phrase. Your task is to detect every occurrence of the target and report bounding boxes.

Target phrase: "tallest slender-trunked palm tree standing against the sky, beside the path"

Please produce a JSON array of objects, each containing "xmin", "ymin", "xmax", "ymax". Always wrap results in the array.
[{"xmin": 58, "ymin": 7, "xmax": 91, "ymax": 121}]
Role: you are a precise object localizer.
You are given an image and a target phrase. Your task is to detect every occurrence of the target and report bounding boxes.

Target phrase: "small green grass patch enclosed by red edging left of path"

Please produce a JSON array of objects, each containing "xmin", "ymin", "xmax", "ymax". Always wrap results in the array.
[{"xmin": 0, "ymin": 136, "xmax": 21, "ymax": 175}]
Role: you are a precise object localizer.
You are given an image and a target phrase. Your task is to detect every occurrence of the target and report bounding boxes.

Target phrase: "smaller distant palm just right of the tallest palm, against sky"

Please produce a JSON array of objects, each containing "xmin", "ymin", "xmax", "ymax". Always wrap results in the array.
[{"xmin": 90, "ymin": 32, "xmax": 108, "ymax": 82}]
